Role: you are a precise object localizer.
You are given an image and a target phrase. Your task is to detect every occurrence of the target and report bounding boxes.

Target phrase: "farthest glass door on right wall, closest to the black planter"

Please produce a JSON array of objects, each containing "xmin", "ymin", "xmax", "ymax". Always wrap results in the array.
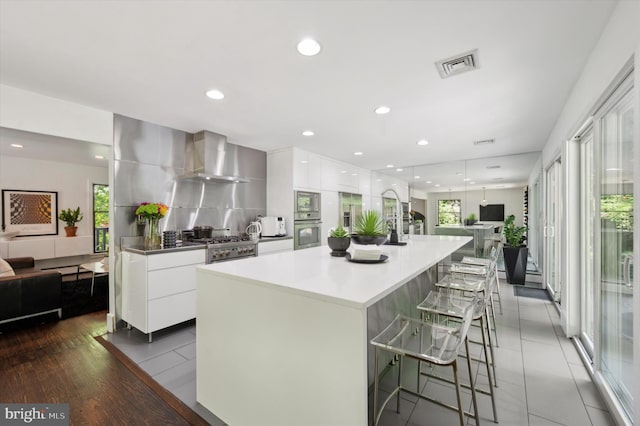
[{"xmin": 544, "ymin": 159, "xmax": 562, "ymax": 303}]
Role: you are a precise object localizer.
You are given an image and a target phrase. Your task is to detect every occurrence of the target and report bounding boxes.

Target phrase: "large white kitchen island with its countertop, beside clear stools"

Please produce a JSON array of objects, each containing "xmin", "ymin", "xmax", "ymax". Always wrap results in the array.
[{"xmin": 196, "ymin": 235, "xmax": 471, "ymax": 426}]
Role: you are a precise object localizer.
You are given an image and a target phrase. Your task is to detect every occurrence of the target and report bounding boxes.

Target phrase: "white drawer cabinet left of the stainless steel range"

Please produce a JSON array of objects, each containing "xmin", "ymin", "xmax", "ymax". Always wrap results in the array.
[{"xmin": 122, "ymin": 249, "xmax": 205, "ymax": 341}]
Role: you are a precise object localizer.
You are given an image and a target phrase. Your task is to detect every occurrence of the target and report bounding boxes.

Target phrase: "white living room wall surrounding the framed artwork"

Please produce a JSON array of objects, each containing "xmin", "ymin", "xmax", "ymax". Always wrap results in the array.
[{"xmin": 0, "ymin": 156, "xmax": 109, "ymax": 258}]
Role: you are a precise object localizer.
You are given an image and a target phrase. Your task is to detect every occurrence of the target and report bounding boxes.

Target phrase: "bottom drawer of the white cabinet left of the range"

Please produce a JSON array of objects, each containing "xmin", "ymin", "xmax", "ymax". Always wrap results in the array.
[{"xmin": 147, "ymin": 290, "xmax": 196, "ymax": 333}]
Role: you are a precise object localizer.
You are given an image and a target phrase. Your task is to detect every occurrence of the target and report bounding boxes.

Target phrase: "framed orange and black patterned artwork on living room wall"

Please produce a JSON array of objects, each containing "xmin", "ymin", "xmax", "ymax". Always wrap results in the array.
[{"xmin": 2, "ymin": 189, "xmax": 58, "ymax": 237}]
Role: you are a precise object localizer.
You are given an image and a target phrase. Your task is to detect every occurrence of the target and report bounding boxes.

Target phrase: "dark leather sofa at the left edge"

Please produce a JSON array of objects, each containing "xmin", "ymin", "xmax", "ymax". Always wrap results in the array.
[{"xmin": 0, "ymin": 257, "xmax": 62, "ymax": 324}]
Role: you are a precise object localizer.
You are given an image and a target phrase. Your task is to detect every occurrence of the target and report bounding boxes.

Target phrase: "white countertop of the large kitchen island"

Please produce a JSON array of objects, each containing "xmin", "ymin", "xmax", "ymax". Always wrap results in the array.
[{"xmin": 198, "ymin": 235, "xmax": 472, "ymax": 308}]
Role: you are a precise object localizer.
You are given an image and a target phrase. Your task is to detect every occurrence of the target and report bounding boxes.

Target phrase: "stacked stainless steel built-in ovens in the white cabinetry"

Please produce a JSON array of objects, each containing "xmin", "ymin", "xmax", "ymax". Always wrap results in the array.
[{"xmin": 293, "ymin": 191, "xmax": 322, "ymax": 250}]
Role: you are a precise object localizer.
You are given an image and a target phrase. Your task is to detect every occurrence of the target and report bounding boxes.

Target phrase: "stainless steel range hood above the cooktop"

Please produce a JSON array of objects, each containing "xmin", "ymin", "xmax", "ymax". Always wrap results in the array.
[{"xmin": 178, "ymin": 130, "xmax": 250, "ymax": 183}]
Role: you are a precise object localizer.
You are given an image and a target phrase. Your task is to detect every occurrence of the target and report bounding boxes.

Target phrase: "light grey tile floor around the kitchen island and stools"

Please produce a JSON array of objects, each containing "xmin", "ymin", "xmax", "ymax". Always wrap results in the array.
[{"xmin": 106, "ymin": 281, "xmax": 615, "ymax": 426}]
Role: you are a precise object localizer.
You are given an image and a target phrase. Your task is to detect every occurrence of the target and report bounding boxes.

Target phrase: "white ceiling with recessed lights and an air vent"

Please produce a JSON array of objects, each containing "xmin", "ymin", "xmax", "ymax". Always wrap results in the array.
[{"xmin": 0, "ymin": 0, "xmax": 615, "ymax": 181}]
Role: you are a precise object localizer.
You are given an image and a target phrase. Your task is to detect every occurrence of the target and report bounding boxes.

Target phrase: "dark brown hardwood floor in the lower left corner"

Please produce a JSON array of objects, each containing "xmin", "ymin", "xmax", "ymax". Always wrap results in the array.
[{"xmin": 0, "ymin": 311, "xmax": 207, "ymax": 425}]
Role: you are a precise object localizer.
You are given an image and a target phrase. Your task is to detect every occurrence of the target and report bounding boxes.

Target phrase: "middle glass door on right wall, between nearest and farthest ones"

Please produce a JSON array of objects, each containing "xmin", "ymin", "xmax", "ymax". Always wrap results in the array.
[{"xmin": 579, "ymin": 128, "xmax": 597, "ymax": 361}]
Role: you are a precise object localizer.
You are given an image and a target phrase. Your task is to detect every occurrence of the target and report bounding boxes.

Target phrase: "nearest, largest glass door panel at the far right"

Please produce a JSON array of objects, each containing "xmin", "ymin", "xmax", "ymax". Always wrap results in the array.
[{"xmin": 597, "ymin": 84, "xmax": 638, "ymax": 415}]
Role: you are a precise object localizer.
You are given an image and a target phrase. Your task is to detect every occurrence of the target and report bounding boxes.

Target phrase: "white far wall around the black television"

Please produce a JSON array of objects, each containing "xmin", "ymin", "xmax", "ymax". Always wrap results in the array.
[{"xmin": 426, "ymin": 188, "xmax": 524, "ymax": 234}]
